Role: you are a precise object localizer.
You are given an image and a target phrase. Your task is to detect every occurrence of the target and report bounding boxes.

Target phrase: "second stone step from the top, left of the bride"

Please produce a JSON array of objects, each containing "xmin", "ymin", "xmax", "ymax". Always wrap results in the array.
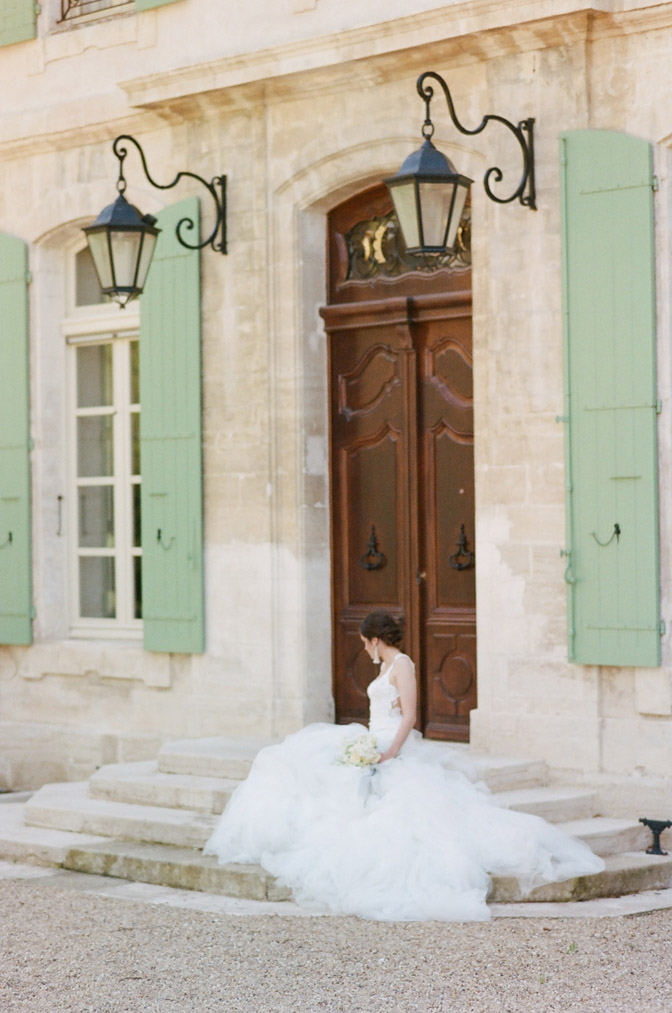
[{"xmin": 89, "ymin": 761, "xmax": 240, "ymax": 814}]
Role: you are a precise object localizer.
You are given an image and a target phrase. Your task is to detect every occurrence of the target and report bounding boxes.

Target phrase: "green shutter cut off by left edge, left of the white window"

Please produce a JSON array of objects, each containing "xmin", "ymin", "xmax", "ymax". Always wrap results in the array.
[{"xmin": 0, "ymin": 234, "xmax": 32, "ymax": 643}]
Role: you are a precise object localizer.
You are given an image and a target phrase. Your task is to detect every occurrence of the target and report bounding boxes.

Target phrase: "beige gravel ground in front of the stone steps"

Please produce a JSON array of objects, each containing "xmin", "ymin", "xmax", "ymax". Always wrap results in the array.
[{"xmin": 0, "ymin": 880, "xmax": 672, "ymax": 1013}]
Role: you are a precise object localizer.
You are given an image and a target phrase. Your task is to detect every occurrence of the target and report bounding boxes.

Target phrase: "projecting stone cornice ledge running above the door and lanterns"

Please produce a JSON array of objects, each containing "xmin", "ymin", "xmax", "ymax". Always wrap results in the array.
[{"xmin": 120, "ymin": 0, "xmax": 672, "ymax": 108}]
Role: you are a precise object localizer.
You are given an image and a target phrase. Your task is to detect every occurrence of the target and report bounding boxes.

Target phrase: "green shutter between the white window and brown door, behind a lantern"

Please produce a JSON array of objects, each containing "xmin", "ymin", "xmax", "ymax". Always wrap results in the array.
[{"xmin": 140, "ymin": 198, "xmax": 204, "ymax": 653}]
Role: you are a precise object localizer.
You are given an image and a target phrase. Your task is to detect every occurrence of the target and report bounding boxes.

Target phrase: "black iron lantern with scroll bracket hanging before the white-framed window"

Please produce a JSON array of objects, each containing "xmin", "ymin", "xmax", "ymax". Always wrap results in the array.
[{"xmin": 82, "ymin": 134, "xmax": 226, "ymax": 307}]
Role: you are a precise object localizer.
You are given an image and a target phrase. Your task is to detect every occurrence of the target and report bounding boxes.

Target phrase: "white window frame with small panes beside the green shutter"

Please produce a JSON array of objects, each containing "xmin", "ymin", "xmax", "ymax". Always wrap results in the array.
[{"xmin": 63, "ymin": 245, "xmax": 143, "ymax": 640}]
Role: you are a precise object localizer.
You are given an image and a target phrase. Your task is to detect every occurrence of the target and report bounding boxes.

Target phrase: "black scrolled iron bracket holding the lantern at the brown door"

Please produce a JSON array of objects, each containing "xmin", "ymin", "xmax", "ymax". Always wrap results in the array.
[{"xmin": 418, "ymin": 70, "xmax": 536, "ymax": 211}]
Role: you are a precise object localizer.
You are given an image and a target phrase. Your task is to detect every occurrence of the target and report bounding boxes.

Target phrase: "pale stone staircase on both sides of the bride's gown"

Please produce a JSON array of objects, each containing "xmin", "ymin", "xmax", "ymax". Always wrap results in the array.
[{"xmin": 0, "ymin": 738, "xmax": 672, "ymax": 903}]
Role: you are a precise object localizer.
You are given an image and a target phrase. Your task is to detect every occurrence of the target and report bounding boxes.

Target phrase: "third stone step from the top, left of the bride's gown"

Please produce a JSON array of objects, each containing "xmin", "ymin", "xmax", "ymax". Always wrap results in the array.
[{"xmin": 24, "ymin": 781, "xmax": 218, "ymax": 848}]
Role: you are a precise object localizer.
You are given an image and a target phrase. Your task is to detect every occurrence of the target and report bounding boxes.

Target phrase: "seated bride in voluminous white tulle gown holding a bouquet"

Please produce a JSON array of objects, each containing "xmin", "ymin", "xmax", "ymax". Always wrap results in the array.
[{"xmin": 205, "ymin": 612, "xmax": 604, "ymax": 921}]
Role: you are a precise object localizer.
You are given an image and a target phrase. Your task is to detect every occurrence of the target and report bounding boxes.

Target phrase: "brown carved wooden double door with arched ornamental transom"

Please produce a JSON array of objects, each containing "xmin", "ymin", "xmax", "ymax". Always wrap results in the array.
[{"xmin": 321, "ymin": 185, "xmax": 476, "ymax": 741}]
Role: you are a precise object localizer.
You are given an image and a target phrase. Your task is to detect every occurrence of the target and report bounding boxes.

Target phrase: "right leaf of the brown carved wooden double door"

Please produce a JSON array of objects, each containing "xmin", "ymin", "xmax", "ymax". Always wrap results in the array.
[{"xmin": 414, "ymin": 295, "xmax": 476, "ymax": 741}]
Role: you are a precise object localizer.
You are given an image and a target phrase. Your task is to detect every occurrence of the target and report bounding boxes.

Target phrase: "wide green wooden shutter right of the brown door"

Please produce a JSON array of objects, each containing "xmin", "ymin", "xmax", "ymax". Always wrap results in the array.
[{"xmin": 561, "ymin": 131, "xmax": 660, "ymax": 666}]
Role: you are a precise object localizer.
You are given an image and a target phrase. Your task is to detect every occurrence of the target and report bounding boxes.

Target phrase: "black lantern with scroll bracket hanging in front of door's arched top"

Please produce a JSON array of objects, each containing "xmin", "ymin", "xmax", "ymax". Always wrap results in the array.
[{"xmin": 385, "ymin": 71, "xmax": 536, "ymax": 257}]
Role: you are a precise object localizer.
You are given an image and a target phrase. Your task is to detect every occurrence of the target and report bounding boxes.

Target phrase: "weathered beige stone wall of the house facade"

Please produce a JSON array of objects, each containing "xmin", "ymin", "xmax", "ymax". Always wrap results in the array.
[{"xmin": 0, "ymin": 0, "xmax": 672, "ymax": 785}]
